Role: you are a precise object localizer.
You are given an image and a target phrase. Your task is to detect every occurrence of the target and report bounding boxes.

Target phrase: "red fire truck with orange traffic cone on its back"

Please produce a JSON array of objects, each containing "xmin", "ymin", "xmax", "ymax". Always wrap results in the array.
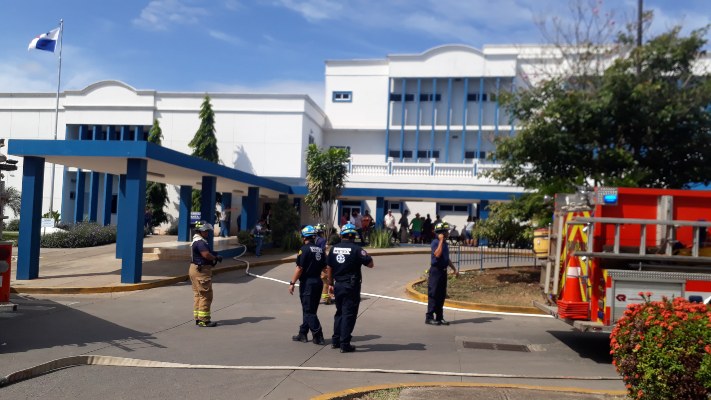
[{"xmin": 535, "ymin": 187, "xmax": 711, "ymax": 332}]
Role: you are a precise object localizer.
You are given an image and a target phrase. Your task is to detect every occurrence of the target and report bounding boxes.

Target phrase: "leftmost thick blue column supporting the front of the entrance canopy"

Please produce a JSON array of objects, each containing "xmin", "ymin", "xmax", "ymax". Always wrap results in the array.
[{"xmin": 15, "ymin": 157, "xmax": 44, "ymax": 280}]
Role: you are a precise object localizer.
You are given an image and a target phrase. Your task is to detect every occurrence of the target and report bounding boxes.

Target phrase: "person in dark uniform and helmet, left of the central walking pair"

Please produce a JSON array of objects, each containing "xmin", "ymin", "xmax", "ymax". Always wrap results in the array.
[{"xmin": 289, "ymin": 225, "xmax": 326, "ymax": 346}]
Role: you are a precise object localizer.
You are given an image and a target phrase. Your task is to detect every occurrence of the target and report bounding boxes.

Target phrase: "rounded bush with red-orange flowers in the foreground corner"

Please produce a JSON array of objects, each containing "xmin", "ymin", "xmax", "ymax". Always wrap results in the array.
[{"xmin": 610, "ymin": 293, "xmax": 711, "ymax": 399}]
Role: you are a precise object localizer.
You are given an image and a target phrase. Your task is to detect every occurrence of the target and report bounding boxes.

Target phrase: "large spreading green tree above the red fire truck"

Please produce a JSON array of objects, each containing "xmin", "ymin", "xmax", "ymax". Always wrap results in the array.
[{"xmin": 492, "ymin": 27, "xmax": 711, "ymax": 194}]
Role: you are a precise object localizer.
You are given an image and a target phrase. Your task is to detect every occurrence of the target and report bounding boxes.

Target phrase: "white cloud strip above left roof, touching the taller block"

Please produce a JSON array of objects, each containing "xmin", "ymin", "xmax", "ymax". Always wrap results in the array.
[{"xmin": 203, "ymin": 80, "xmax": 325, "ymax": 108}]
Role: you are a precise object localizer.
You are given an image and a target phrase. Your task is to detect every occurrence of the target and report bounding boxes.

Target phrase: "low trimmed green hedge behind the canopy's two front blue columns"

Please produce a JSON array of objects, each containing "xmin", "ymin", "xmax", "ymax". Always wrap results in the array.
[{"xmin": 40, "ymin": 222, "xmax": 116, "ymax": 248}]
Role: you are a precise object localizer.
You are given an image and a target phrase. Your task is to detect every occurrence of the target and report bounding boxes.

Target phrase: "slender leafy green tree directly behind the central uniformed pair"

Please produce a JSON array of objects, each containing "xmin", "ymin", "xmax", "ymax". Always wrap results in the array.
[{"xmin": 304, "ymin": 144, "xmax": 350, "ymax": 237}]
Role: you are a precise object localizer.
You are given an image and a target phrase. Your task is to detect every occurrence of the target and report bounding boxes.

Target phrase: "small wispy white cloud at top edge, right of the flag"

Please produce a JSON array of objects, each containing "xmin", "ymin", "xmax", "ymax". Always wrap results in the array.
[{"xmin": 133, "ymin": 0, "xmax": 208, "ymax": 31}]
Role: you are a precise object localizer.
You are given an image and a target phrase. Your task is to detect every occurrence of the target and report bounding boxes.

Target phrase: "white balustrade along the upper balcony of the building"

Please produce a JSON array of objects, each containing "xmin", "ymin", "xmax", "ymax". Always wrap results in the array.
[{"xmin": 348, "ymin": 158, "xmax": 500, "ymax": 178}]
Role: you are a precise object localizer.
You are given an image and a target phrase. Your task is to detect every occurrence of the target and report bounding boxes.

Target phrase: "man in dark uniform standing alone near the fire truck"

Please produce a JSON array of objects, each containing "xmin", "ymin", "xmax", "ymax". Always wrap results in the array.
[{"xmin": 425, "ymin": 221, "xmax": 459, "ymax": 325}]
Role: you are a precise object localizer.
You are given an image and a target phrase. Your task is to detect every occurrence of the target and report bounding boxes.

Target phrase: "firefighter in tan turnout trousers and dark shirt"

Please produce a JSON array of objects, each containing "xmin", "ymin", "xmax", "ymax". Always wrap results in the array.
[{"xmin": 189, "ymin": 221, "xmax": 222, "ymax": 328}]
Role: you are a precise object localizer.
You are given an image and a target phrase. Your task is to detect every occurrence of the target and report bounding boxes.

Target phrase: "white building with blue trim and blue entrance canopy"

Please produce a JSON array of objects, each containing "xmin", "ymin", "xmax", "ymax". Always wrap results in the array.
[{"xmin": 0, "ymin": 45, "xmax": 556, "ymax": 281}]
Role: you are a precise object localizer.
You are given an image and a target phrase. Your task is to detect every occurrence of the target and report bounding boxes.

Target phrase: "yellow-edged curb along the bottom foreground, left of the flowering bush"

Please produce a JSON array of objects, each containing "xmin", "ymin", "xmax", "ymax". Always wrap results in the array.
[{"xmin": 311, "ymin": 382, "xmax": 627, "ymax": 400}]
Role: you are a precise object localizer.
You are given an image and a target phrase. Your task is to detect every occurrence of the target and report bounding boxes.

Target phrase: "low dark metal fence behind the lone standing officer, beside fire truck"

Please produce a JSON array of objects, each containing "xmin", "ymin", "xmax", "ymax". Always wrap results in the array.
[{"xmin": 449, "ymin": 245, "xmax": 537, "ymax": 270}]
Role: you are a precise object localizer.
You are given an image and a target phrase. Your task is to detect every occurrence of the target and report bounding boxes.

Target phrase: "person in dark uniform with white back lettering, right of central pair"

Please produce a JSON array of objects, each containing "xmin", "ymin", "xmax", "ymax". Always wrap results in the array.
[{"xmin": 326, "ymin": 224, "xmax": 374, "ymax": 353}]
